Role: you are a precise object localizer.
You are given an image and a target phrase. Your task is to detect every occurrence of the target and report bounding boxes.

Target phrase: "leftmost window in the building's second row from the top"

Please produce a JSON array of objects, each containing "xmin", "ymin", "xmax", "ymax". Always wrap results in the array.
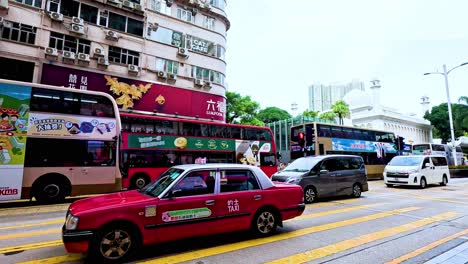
[{"xmin": 0, "ymin": 21, "xmax": 37, "ymax": 44}]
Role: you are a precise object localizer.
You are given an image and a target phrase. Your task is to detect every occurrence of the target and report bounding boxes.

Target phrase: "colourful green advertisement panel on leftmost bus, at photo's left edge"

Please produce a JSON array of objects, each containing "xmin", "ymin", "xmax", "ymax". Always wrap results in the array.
[{"xmin": 0, "ymin": 83, "xmax": 31, "ymax": 201}]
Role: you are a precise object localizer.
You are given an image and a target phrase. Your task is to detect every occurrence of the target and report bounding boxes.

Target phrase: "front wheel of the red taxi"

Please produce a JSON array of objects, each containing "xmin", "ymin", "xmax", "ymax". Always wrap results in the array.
[{"xmin": 90, "ymin": 223, "xmax": 141, "ymax": 263}]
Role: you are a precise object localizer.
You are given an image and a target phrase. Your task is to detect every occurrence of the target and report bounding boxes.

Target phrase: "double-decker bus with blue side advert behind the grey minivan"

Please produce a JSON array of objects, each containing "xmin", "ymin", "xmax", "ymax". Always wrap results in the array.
[{"xmin": 290, "ymin": 122, "xmax": 398, "ymax": 178}]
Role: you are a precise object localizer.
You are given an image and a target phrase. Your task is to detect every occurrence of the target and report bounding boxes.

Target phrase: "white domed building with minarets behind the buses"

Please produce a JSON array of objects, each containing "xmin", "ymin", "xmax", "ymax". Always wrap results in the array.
[{"xmin": 343, "ymin": 80, "xmax": 432, "ymax": 144}]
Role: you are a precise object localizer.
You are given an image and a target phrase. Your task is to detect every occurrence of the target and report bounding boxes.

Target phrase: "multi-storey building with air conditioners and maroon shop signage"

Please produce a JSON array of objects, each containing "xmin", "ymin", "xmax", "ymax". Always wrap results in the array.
[{"xmin": 0, "ymin": 0, "xmax": 230, "ymax": 121}]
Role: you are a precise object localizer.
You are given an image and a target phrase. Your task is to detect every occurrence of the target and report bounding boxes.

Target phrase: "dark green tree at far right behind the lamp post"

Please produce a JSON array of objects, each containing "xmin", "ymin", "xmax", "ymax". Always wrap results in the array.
[{"xmin": 424, "ymin": 103, "xmax": 468, "ymax": 142}]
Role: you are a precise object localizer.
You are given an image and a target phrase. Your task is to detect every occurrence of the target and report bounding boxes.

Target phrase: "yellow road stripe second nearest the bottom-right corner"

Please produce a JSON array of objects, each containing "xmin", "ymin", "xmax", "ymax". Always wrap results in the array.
[{"xmin": 267, "ymin": 212, "xmax": 457, "ymax": 264}]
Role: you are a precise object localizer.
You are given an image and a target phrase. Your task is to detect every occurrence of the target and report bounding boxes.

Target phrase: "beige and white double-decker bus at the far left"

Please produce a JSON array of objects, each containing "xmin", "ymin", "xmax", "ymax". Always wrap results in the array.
[{"xmin": 0, "ymin": 80, "xmax": 122, "ymax": 202}]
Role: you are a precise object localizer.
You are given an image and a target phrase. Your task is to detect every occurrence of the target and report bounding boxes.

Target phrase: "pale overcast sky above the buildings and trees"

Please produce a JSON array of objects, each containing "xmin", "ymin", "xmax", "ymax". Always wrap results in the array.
[{"xmin": 226, "ymin": 0, "xmax": 468, "ymax": 115}]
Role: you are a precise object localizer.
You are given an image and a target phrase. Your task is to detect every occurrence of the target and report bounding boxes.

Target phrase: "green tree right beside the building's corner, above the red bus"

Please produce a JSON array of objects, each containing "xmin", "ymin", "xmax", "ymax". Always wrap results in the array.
[{"xmin": 226, "ymin": 91, "xmax": 260, "ymax": 124}]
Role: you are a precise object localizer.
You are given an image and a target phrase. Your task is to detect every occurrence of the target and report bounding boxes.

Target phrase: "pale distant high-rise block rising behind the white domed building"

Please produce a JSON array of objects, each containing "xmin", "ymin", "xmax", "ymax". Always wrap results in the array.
[{"xmin": 309, "ymin": 80, "xmax": 364, "ymax": 112}]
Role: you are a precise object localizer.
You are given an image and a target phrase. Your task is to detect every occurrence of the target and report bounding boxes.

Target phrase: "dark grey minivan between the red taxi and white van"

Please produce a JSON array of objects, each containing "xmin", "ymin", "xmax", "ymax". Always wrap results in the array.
[{"xmin": 272, "ymin": 155, "xmax": 369, "ymax": 203}]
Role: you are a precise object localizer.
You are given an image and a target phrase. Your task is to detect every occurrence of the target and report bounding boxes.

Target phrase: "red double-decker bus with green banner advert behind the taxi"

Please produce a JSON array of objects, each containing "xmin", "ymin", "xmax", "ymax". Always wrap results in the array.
[{"xmin": 120, "ymin": 110, "xmax": 277, "ymax": 189}]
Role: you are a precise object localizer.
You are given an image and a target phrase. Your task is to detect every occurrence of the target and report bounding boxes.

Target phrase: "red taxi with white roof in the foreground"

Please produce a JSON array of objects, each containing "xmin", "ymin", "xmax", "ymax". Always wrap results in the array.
[{"xmin": 62, "ymin": 164, "xmax": 305, "ymax": 262}]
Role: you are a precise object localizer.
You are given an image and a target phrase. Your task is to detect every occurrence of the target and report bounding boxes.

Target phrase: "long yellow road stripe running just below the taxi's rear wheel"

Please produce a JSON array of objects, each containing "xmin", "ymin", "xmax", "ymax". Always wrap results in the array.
[{"xmin": 137, "ymin": 207, "xmax": 420, "ymax": 264}]
